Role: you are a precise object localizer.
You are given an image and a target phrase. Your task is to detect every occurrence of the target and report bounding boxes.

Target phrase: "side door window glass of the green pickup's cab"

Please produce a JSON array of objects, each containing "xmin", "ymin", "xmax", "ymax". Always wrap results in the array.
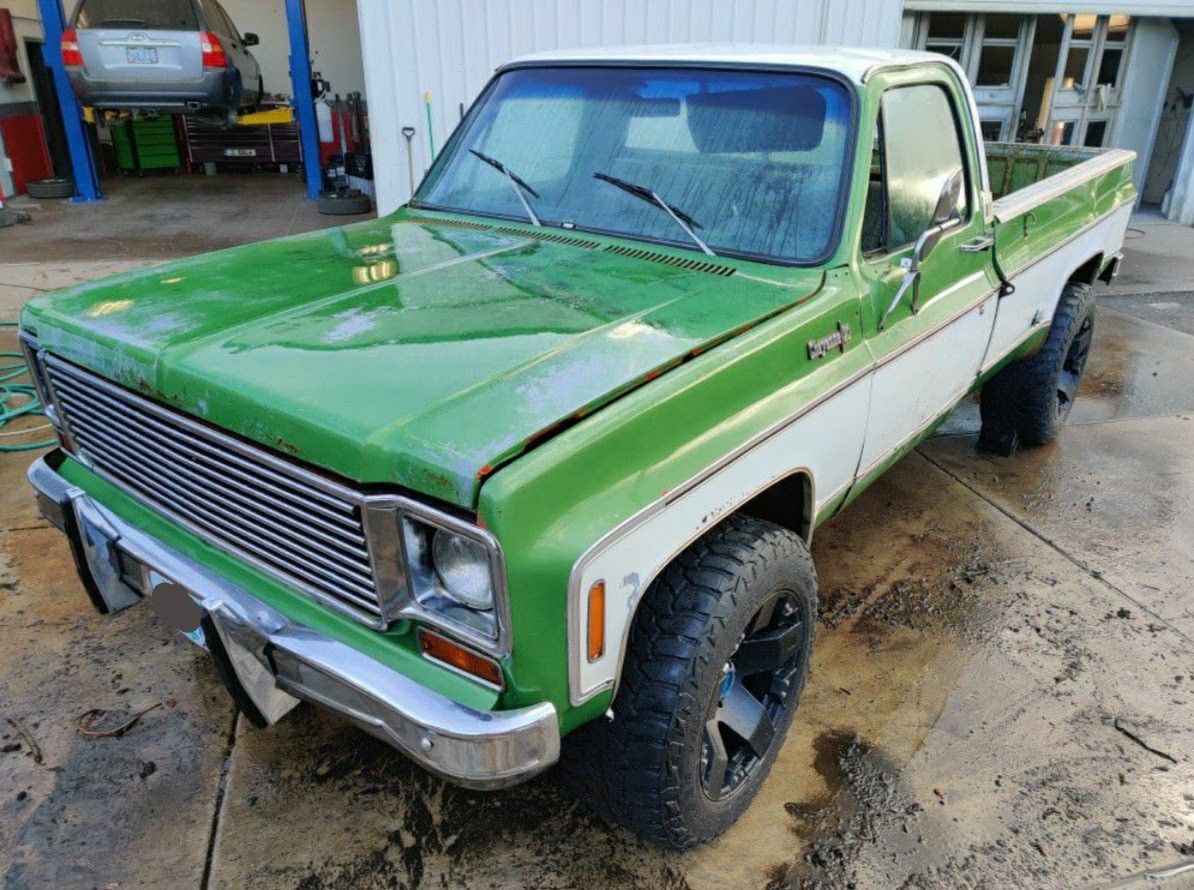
[{"xmin": 862, "ymin": 84, "xmax": 970, "ymax": 253}]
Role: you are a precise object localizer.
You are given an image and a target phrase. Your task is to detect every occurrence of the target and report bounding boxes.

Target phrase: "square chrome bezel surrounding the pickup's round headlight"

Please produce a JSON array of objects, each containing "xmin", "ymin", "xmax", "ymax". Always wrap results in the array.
[{"xmin": 365, "ymin": 496, "xmax": 511, "ymax": 658}]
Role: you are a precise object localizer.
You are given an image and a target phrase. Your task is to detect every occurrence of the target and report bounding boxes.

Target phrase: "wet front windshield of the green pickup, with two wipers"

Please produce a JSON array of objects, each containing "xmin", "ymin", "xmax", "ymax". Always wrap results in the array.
[{"xmin": 417, "ymin": 67, "xmax": 850, "ymax": 263}]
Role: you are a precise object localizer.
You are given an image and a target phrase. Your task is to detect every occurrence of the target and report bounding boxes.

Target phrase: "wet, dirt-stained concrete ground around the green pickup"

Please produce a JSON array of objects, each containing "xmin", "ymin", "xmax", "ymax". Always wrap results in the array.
[{"xmin": 0, "ymin": 195, "xmax": 1194, "ymax": 890}]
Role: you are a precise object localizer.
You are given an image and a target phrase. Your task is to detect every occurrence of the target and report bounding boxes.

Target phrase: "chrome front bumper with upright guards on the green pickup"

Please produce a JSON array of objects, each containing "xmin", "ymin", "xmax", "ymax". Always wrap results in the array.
[{"xmin": 29, "ymin": 452, "xmax": 560, "ymax": 788}]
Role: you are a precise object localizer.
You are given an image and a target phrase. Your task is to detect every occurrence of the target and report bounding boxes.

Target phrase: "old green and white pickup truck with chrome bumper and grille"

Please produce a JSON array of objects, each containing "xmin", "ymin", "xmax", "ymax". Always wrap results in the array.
[{"xmin": 21, "ymin": 47, "xmax": 1135, "ymax": 847}]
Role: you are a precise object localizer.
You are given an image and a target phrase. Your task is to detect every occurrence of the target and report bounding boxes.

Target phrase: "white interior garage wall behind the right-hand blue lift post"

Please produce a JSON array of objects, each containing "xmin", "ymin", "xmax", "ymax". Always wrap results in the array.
[{"xmin": 221, "ymin": 0, "xmax": 365, "ymax": 97}]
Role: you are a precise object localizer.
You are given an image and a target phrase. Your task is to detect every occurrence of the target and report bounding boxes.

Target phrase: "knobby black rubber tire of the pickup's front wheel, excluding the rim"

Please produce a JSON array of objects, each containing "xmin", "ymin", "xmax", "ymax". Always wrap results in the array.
[{"xmin": 561, "ymin": 515, "xmax": 817, "ymax": 849}]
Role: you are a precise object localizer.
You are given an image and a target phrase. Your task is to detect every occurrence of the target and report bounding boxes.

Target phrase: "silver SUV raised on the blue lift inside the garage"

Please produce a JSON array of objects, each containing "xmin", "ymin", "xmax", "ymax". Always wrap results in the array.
[{"xmin": 62, "ymin": 0, "xmax": 264, "ymax": 113}]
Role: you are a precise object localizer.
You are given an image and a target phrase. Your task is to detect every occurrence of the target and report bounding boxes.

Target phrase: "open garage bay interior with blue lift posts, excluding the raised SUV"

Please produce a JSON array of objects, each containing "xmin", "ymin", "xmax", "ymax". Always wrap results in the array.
[{"xmin": 0, "ymin": 0, "xmax": 373, "ymax": 252}]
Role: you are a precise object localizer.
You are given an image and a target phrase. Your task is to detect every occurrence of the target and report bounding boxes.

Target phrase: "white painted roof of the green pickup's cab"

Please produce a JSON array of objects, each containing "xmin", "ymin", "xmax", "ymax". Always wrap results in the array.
[{"xmin": 503, "ymin": 43, "xmax": 949, "ymax": 82}]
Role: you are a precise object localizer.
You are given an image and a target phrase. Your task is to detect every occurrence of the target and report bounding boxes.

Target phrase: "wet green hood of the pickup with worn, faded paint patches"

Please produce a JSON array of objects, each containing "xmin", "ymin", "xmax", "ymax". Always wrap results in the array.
[{"xmin": 23, "ymin": 210, "xmax": 820, "ymax": 508}]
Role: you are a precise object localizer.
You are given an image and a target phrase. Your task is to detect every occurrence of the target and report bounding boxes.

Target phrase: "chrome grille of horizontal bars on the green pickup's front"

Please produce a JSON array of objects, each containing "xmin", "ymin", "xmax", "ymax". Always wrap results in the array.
[{"xmin": 45, "ymin": 355, "xmax": 386, "ymax": 627}]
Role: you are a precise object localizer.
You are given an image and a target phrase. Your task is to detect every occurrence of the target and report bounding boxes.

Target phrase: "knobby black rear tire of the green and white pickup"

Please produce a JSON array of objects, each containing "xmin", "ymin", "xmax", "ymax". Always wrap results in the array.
[{"xmin": 979, "ymin": 281, "xmax": 1095, "ymax": 453}]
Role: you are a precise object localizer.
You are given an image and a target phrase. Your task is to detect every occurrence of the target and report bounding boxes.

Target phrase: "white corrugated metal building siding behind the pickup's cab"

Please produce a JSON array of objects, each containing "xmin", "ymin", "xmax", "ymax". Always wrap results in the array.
[{"xmin": 357, "ymin": 0, "xmax": 904, "ymax": 213}]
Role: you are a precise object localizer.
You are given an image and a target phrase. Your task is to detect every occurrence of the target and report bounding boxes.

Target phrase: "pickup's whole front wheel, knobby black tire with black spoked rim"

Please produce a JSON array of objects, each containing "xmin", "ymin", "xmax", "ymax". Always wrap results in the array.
[{"xmin": 562, "ymin": 506, "xmax": 817, "ymax": 849}]
